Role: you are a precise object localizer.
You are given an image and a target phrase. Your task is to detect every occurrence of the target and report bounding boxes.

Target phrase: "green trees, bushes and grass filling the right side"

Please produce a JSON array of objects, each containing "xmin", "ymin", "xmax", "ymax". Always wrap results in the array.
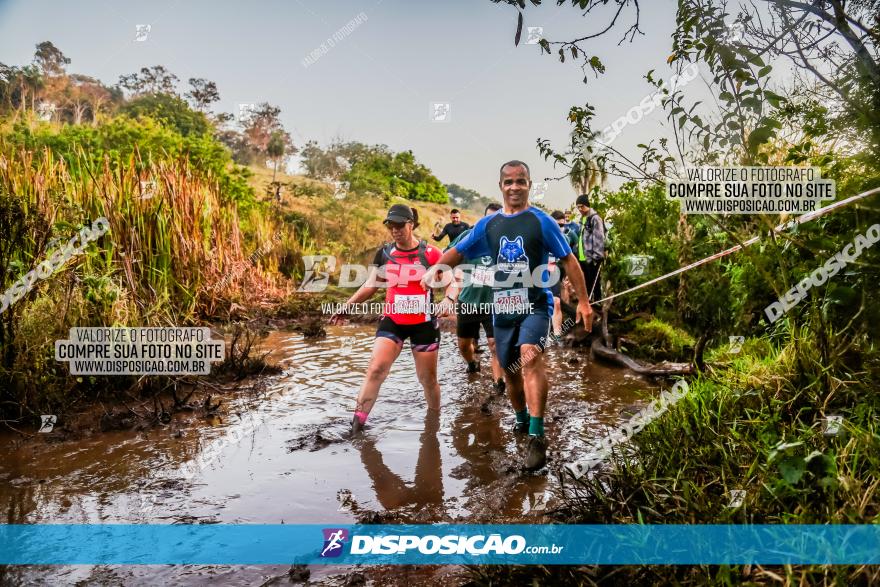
[{"xmin": 482, "ymin": 0, "xmax": 880, "ymax": 585}]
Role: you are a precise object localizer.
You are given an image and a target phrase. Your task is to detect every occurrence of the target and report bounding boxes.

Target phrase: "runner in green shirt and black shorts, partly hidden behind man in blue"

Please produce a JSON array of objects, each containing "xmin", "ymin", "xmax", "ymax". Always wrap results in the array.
[{"xmin": 446, "ymin": 203, "xmax": 505, "ymax": 393}]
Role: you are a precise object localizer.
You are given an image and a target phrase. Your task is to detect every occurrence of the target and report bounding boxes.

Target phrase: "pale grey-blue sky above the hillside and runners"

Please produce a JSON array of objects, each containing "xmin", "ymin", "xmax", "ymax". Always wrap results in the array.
[{"xmin": 0, "ymin": 0, "xmax": 688, "ymax": 208}]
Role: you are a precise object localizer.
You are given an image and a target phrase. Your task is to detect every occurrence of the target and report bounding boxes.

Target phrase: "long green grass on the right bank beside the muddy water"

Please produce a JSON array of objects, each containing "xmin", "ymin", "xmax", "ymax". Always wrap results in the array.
[{"xmin": 470, "ymin": 328, "xmax": 880, "ymax": 585}]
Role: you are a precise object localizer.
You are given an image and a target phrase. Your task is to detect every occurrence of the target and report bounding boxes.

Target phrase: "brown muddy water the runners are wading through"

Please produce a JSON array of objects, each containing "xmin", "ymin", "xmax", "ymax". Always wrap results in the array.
[{"xmin": 0, "ymin": 325, "xmax": 652, "ymax": 585}]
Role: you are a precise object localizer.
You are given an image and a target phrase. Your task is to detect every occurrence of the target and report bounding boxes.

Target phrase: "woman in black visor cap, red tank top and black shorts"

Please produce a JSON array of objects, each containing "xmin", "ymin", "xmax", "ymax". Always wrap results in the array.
[{"xmin": 330, "ymin": 204, "xmax": 441, "ymax": 434}]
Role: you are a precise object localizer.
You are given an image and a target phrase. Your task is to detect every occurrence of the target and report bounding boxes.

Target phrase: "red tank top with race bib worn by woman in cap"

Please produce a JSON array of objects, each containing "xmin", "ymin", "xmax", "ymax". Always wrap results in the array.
[{"xmin": 373, "ymin": 245, "xmax": 443, "ymax": 324}]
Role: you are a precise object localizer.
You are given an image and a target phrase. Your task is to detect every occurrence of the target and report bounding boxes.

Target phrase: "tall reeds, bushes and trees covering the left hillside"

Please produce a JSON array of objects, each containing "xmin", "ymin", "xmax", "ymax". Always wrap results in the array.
[{"xmin": 0, "ymin": 42, "xmax": 468, "ymax": 428}]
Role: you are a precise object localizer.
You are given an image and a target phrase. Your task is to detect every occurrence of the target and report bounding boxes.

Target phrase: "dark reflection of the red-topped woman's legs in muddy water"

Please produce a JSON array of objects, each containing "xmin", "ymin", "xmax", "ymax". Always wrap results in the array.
[{"xmin": 360, "ymin": 410, "xmax": 443, "ymax": 510}]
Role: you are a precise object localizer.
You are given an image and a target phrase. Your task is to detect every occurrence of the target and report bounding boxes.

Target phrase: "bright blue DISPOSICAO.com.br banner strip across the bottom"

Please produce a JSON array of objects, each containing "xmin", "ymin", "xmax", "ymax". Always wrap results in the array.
[{"xmin": 0, "ymin": 524, "xmax": 880, "ymax": 565}]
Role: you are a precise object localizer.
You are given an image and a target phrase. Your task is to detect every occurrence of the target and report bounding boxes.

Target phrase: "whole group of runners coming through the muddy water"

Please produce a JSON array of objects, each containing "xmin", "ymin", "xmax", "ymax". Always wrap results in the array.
[{"xmin": 330, "ymin": 160, "xmax": 604, "ymax": 470}]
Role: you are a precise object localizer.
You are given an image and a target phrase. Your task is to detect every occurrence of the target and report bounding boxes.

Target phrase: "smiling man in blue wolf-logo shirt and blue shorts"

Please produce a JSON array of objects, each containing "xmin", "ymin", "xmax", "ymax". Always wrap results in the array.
[{"xmin": 422, "ymin": 160, "xmax": 593, "ymax": 470}]
